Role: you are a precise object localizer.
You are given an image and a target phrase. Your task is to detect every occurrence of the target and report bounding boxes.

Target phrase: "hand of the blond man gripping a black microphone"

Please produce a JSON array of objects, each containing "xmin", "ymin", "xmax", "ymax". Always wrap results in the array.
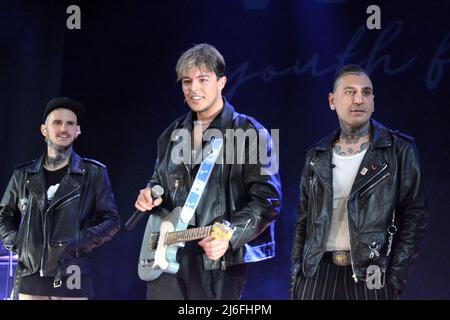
[{"xmin": 125, "ymin": 184, "xmax": 164, "ymax": 231}]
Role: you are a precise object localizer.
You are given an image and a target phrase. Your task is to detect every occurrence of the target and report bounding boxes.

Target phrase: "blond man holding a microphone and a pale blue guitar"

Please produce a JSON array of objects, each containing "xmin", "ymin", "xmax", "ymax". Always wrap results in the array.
[{"xmin": 135, "ymin": 44, "xmax": 281, "ymax": 300}]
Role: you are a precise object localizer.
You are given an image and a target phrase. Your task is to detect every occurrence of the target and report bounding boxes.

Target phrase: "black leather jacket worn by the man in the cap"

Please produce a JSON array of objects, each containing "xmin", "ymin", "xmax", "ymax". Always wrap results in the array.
[{"xmin": 0, "ymin": 152, "xmax": 120, "ymax": 276}]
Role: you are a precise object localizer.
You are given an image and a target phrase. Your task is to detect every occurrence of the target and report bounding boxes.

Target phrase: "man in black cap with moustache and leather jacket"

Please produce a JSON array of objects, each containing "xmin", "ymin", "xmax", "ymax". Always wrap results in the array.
[{"xmin": 0, "ymin": 97, "xmax": 120, "ymax": 300}]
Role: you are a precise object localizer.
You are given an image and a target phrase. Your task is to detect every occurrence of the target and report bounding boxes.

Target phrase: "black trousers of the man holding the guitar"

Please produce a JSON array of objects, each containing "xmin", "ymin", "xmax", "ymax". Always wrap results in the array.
[{"xmin": 147, "ymin": 242, "xmax": 247, "ymax": 300}]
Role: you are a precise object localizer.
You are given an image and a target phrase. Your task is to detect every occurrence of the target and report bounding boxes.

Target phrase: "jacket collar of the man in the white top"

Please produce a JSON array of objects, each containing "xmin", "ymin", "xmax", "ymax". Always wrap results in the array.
[{"xmin": 316, "ymin": 119, "xmax": 392, "ymax": 151}]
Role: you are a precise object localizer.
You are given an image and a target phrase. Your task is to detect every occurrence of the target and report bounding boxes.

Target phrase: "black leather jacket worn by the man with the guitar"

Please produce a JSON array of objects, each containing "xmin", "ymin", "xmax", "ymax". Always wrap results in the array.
[{"xmin": 149, "ymin": 100, "xmax": 281, "ymax": 270}]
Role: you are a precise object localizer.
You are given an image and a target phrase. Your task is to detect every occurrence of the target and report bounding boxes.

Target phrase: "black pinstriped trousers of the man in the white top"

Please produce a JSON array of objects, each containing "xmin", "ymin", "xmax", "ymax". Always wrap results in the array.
[{"xmin": 293, "ymin": 254, "xmax": 398, "ymax": 300}]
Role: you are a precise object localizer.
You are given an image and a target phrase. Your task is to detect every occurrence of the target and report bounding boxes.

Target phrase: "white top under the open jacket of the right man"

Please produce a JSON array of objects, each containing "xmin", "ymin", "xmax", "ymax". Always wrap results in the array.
[{"xmin": 325, "ymin": 149, "xmax": 367, "ymax": 251}]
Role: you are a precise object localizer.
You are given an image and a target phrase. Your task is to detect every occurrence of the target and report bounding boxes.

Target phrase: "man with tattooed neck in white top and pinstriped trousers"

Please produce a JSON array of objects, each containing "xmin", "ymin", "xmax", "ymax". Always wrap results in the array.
[{"xmin": 291, "ymin": 65, "xmax": 428, "ymax": 300}]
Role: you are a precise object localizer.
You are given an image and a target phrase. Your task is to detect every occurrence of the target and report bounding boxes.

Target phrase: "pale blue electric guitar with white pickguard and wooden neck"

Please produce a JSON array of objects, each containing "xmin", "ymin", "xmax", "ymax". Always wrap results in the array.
[{"xmin": 138, "ymin": 207, "xmax": 235, "ymax": 281}]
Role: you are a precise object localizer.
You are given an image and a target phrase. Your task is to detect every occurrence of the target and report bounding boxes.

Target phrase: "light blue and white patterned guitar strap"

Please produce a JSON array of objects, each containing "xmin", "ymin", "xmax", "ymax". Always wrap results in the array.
[{"xmin": 175, "ymin": 138, "xmax": 223, "ymax": 231}]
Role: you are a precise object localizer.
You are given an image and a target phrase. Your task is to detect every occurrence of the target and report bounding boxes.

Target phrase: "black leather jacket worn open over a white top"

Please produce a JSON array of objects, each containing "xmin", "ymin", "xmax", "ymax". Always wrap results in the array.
[{"xmin": 292, "ymin": 120, "xmax": 428, "ymax": 289}]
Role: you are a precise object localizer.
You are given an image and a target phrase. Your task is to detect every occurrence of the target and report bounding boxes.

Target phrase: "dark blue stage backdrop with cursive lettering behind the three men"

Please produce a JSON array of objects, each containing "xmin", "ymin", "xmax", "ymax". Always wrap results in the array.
[{"xmin": 0, "ymin": 0, "xmax": 450, "ymax": 299}]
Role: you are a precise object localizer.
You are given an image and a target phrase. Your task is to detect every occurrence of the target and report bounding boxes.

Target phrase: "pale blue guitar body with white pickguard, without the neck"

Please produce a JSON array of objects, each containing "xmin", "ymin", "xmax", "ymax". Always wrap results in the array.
[{"xmin": 138, "ymin": 207, "xmax": 184, "ymax": 281}]
